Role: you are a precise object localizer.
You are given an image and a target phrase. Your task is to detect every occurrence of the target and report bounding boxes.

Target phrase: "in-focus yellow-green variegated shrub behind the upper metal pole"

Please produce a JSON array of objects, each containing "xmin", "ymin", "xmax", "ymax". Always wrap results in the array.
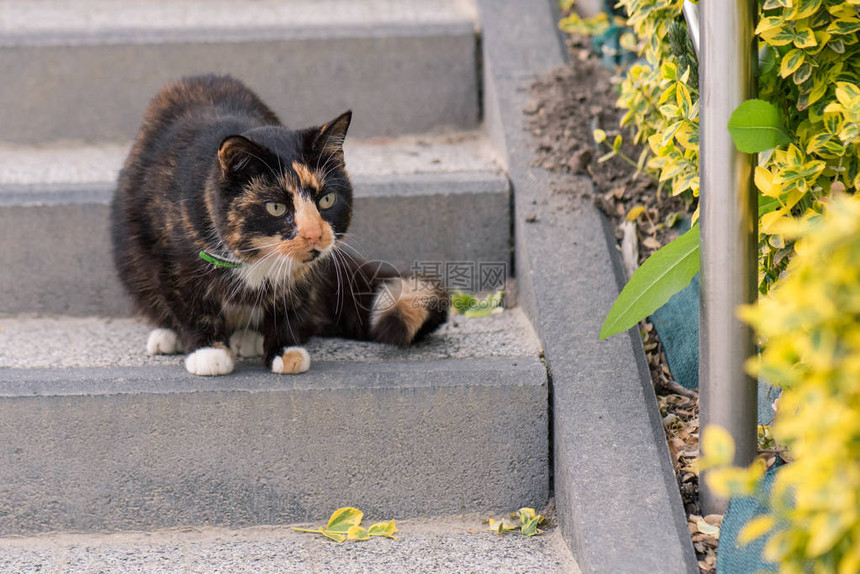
[{"xmin": 604, "ymin": 0, "xmax": 860, "ymax": 293}]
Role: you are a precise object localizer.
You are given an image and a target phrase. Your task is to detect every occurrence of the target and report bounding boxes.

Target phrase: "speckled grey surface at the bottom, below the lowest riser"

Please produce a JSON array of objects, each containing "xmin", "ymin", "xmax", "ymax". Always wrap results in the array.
[{"xmin": 0, "ymin": 515, "xmax": 579, "ymax": 574}]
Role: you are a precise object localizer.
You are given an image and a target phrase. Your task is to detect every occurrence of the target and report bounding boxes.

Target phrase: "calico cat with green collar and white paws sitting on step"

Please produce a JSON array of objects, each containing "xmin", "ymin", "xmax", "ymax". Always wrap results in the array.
[{"xmin": 111, "ymin": 75, "xmax": 447, "ymax": 375}]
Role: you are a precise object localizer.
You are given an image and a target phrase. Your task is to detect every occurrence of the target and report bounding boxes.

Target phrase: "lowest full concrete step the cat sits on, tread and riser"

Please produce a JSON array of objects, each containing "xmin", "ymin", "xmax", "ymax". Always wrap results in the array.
[{"xmin": 0, "ymin": 308, "xmax": 549, "ymax": 536}]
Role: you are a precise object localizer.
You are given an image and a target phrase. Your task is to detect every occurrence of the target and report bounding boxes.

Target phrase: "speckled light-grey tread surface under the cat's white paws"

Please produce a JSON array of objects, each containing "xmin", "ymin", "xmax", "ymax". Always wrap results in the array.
[{"xmin": 0, "ymin": 308, "xmax": 540, "ymax": 372}]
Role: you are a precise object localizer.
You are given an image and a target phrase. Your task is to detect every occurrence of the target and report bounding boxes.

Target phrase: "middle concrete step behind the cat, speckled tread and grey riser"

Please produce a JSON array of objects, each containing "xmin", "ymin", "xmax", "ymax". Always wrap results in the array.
[{"xmin": 0, "ymin": 132, "xmax": 510, "ymax": 316}]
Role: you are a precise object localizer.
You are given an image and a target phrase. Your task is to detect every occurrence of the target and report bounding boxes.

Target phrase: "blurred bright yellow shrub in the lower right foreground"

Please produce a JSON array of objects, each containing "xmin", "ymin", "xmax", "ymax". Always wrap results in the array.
[{"xmin": 703, "ymin": 194, "xmax": 860, "ymax": 574}]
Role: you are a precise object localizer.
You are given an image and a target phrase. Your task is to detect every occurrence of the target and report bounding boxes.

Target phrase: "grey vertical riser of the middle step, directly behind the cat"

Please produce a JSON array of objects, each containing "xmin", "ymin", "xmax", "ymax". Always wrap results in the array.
[{"xmin": 0, "ymin": 174, "xmax": 510, "ymax": 316}]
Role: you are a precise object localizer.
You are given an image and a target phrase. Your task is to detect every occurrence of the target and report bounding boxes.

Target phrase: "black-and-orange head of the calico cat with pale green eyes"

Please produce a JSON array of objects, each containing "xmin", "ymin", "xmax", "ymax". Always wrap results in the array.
[{"xmin": 215, "ymin": 111, "xmax": 352, "ymax": 280}]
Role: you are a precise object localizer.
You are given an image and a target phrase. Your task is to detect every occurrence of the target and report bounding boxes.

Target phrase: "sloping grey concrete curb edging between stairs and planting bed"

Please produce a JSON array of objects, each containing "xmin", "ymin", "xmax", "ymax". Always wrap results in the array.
[{"xmin": 478, "ymin": 0, "xmax": 698, "ymax": 574}]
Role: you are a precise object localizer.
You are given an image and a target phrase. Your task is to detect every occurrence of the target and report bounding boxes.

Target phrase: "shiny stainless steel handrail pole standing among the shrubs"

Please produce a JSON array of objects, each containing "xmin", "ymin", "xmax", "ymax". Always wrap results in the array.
[{"xmin": 699, "ymin": 0, "xmax": 758, "ymax": 514}]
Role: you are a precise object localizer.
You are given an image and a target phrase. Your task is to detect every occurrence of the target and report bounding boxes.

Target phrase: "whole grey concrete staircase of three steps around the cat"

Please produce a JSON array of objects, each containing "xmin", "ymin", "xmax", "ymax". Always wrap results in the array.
[{"xmin": 0, "ymin": 0, "xmax": 549, "ymax": 535}]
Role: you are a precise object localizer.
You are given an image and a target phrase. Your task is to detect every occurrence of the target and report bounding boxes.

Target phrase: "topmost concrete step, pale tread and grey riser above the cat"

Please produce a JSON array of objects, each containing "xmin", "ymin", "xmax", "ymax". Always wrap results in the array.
[{"xmin": 0, "ymin": 0, "xmax": 479, "ymax": 144}]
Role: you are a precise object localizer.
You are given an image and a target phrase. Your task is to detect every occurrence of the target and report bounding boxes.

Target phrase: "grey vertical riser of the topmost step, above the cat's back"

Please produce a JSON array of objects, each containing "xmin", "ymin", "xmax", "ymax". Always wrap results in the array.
[{"xmin": 0, "ymin": 23, "xmax": 479, "ymax": 144}]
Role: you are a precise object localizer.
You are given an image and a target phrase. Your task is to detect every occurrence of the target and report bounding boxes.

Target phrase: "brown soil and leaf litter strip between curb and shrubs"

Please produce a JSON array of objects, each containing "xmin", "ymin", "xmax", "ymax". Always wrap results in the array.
[{"xmin": 523, "ymin": 36, "xmax": 722, "ymax": 573}]
